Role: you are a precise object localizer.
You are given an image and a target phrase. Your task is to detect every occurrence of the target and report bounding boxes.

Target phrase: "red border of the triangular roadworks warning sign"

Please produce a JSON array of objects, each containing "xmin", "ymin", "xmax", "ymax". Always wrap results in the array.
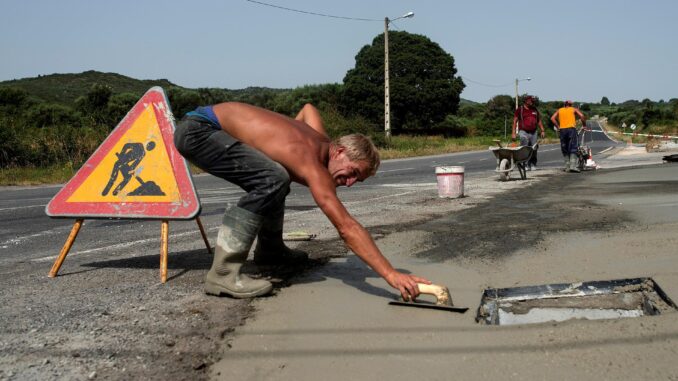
[{"xmin": 45, "ymin": 86, "xmax": 201, "ymax": 220}]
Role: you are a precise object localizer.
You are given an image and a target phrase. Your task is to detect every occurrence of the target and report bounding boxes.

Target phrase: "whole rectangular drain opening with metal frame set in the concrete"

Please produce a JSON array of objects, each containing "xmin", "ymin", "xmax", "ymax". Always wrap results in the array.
[{"xmin": 476, "ymin": 278, "xmax": 677, "ymax": 325}]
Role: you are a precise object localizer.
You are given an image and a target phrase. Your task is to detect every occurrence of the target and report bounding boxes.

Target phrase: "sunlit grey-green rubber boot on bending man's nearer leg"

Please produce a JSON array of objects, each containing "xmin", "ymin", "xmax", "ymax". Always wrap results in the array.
[{"xmin": 205, "ymin": 207, "xmax": 273, "ymax": 298}]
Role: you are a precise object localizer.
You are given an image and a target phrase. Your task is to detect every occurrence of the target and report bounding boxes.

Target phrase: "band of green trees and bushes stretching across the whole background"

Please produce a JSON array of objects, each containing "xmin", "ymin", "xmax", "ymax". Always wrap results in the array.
[{"xmin": 0, "ymin": 31, "xmax": 678, "ymax": 168}]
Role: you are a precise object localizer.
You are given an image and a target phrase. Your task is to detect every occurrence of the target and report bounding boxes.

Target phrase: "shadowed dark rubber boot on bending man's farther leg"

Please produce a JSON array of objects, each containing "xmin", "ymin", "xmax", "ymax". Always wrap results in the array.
[{"xmin": 254, "ymin": 209, "xmax": 308, "ymax": 266}]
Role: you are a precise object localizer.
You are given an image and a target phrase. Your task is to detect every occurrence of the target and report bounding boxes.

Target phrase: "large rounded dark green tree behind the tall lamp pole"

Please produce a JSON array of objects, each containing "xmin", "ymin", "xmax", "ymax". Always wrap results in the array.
[{"xmin": 341, "ymin": 32, "xmax": 464, "ymax": 133}]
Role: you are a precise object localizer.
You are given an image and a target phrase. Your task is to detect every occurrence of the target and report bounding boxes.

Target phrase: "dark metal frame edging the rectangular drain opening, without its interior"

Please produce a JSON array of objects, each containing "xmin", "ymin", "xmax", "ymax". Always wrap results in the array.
[{"xmin": 475, "ymin": 277, "xmax": 678, "ymax": 325}]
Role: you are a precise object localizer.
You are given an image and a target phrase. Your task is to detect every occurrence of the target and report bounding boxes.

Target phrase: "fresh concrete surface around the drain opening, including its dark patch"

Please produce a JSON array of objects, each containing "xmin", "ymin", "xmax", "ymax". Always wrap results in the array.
[{"xmin": 211, "ymin": 156, "xmax": 678, "ymax": 380}]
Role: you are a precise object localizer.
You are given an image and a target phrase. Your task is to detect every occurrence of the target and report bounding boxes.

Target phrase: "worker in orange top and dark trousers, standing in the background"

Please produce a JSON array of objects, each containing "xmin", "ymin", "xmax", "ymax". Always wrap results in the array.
[{"xmin": 551, "ymin": 100, "xmax": 586, "ymax": 173}]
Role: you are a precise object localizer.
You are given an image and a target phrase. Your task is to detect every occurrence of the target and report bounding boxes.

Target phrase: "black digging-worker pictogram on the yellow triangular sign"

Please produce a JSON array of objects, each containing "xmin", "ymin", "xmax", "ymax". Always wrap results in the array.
[{"xmin": 101, "ymin": 141, "xmax": 164, "ymax": 196}]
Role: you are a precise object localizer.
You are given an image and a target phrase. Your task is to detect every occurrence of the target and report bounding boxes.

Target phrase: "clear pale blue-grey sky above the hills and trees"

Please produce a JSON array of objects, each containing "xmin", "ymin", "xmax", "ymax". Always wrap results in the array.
[{"xmin": 0, "ymin": 0, "xmax": 678, "ymax": 102}]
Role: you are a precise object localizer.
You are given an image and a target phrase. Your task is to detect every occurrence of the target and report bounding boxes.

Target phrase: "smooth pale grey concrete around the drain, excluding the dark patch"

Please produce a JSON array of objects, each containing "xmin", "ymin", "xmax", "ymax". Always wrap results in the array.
[{"xmin": 210, "ymin": 148, "xmax": 678, "ymax": 381}]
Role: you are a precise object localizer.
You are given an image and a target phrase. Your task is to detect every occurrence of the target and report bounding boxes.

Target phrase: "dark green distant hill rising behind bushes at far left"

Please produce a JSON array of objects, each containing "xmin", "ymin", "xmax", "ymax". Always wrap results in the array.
[{"xmin": 0, "ymin": 70, "xmax": 180, "ymax": 105}]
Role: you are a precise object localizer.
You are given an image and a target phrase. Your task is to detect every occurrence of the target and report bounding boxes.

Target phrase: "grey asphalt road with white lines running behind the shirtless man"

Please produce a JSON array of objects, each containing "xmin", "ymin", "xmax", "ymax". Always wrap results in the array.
[{"xmin": 0, "ymin": 121, "xmax": 616, "ymax": 265}]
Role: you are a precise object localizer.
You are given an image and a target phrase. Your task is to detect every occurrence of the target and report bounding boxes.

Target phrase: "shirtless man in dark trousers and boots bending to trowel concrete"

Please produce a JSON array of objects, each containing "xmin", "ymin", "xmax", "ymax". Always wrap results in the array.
[{"xmin": 174, "ymin": 102, "xmax": 431, "ymax": 300}]
